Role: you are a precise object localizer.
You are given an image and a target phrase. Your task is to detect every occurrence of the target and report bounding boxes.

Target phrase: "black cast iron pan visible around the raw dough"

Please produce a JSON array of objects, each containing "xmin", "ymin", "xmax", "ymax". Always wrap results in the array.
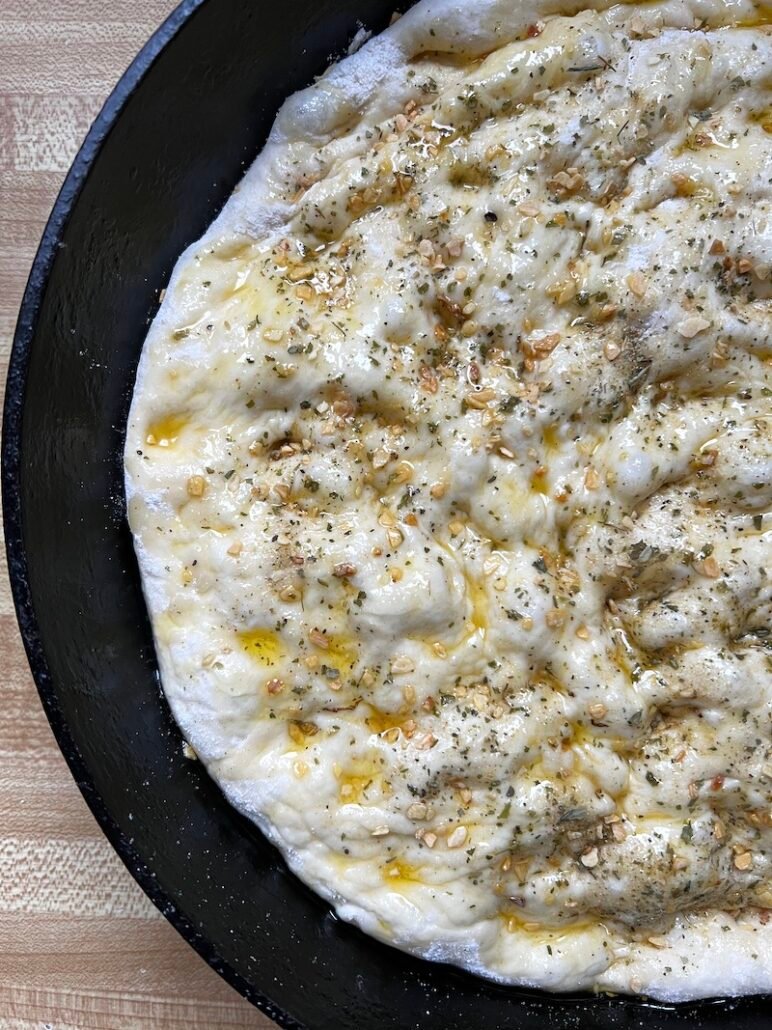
[{"xmin": 2, "ymin": 0, "xmax": 772, "ymax": 1030}]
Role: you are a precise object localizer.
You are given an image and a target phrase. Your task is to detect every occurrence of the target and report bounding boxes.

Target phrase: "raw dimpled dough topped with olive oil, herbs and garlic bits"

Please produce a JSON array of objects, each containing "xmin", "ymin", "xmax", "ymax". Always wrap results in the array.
[{"xmin": 126, "ymin": 0, "xmax": 772, "ymax": 1000}]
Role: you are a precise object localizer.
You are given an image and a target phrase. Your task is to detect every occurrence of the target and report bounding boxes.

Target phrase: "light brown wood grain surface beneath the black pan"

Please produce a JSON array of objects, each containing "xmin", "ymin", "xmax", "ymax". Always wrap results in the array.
[{"xmin": 0, "ymin": 0, "xmax": 274, "ymax": 1030}]
